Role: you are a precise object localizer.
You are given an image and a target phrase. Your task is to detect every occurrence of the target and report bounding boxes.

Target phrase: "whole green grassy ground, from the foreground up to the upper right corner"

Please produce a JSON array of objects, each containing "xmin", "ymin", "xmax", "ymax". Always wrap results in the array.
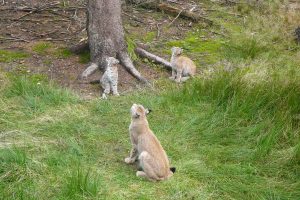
[{"xmin": 0, "ymin": 2, "xmax": 300, "ymax": 199}]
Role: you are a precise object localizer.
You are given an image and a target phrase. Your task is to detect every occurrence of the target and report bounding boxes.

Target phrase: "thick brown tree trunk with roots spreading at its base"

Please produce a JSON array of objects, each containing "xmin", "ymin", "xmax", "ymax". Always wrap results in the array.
[{"xmin": 82, "ymin": 0, "xmax": 147, "ymax": 82}]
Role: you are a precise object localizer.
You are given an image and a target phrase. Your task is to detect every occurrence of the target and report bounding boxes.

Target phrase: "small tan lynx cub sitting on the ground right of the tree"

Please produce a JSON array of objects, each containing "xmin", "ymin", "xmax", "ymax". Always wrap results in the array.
[{"xmin": 170, "ymin": 47, "xmax": 196, "ymax": 83}]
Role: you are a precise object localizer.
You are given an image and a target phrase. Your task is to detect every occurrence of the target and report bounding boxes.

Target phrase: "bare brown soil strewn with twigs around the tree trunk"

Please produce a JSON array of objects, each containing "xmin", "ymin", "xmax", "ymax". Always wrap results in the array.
[{"xmin": 0, "ymin": 0, "xmax": 204, "ymax": 98}]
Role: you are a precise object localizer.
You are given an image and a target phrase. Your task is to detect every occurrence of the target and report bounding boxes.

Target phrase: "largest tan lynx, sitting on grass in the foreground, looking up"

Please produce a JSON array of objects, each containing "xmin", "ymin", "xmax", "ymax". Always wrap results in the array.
[{"xmin": 125, "ymin": 104, "xmax": 173, "ymax": 181}]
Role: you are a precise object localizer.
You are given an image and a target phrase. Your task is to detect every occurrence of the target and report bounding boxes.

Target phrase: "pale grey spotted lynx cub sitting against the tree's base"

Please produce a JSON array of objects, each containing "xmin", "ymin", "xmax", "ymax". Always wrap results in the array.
[{"xmin": 100, "ymin": 57, "xmax": 119, "ymax": 99}]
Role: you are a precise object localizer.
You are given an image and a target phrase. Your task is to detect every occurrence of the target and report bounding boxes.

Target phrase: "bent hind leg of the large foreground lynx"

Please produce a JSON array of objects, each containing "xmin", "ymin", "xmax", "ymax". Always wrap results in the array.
[{"xmin": 136, "ymin": 151, "xmax": 160, "ymax": 181}]
